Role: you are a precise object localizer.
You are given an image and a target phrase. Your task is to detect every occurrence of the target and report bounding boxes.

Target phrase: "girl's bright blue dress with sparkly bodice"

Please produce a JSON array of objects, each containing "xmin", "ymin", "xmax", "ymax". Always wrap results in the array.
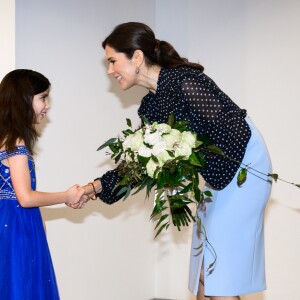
[{"xmin": 0, "ymin": 146, "xmax": 59, "ymax": 300}]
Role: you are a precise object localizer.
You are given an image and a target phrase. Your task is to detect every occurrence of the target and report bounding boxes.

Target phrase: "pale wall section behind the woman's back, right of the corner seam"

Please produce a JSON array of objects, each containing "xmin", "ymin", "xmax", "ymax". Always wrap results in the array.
[{"xmin": 156, "ymin": 0, "xmax": 300, "ymax": 300}]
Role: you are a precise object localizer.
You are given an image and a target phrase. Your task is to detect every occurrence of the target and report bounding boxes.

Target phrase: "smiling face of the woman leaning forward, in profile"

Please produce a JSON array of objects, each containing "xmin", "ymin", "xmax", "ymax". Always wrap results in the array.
[{"xmin": 105, "ymin": 46, "xmax": 137, "ymax": 90}]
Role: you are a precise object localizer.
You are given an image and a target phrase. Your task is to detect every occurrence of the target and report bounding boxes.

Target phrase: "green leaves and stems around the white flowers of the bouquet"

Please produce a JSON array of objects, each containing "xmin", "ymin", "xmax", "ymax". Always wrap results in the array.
[{"xmin": 97, "ymin": 114, "xmax": 300, "ymax": 238}]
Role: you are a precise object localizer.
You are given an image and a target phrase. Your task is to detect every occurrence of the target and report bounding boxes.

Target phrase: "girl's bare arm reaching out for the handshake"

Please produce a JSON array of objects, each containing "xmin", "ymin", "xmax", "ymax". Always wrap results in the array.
[{"xmin": 8, "ymin": 155, "xmax": 78, "ymax": 207}]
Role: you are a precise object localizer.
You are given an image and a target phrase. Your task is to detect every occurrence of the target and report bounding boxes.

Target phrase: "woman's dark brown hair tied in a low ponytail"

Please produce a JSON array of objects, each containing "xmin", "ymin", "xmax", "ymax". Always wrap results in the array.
[{"xmin": 102, "ymin": 22, "xmax": 204, "ymax": 72}]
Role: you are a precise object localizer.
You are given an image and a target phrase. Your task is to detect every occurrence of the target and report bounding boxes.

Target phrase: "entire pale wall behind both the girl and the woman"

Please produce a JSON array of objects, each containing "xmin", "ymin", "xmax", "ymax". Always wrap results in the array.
[{"xmin": 0, "ymin": 0, "xmax": 300, "ymax": 300}]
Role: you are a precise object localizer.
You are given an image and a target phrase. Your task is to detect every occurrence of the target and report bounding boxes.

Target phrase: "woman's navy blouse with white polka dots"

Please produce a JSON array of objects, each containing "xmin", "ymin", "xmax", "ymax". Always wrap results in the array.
[{"xmin": 98, "ymin": 67, "xmax": 251, "ymax": 204}]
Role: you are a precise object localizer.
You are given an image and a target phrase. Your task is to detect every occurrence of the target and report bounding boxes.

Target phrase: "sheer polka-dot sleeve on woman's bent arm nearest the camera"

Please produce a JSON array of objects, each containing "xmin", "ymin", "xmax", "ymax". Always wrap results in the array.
[{"xmin": 181, "ymin": 74, "xmax": 251, "ymax": 189}]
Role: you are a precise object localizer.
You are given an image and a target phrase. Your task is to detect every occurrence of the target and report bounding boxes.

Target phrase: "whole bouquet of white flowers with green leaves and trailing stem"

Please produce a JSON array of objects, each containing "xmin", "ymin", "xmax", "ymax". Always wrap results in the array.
[{"xmin": 98, "ymin": 114, "xmax": 299, "ymax": 237}]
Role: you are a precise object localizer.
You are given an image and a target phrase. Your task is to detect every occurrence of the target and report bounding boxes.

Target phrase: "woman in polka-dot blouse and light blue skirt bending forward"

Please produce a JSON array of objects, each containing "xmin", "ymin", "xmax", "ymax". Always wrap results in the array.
[{"xmin": 79, "ymin": 22, "xmax": 271, "ymax": 300}]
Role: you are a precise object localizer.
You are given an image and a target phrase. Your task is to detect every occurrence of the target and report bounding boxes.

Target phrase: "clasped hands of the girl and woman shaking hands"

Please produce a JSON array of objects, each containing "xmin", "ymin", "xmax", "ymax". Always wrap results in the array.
[{"xmin": 65, "ymin": 179, "xmax": 102, "ymax": 209}]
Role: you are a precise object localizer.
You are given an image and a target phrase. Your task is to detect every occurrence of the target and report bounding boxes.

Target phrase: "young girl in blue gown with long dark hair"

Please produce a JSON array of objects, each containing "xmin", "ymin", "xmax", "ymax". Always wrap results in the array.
[{"xmin": 0, "ymin": 69, "xmax": 82, "ymax": 300}]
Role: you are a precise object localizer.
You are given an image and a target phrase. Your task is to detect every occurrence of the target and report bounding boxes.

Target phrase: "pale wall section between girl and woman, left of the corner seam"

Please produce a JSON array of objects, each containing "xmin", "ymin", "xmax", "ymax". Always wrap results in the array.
[{"xmin": 16, "ymin": 0, "xmax": 155, "ymax": 300}]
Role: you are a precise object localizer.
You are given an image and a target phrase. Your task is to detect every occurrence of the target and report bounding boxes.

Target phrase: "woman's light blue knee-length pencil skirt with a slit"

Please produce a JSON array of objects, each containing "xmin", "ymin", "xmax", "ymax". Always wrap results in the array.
[{"xmin": 189, "ymin": 117, "xmax": 272, "ymax": 296}]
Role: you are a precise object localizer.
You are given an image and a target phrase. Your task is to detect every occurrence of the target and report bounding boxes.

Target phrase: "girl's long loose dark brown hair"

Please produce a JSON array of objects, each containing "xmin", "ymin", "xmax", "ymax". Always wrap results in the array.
[{"xmin": 0, "ymin": 69, "xmax": 51, "ymax": 154}]
